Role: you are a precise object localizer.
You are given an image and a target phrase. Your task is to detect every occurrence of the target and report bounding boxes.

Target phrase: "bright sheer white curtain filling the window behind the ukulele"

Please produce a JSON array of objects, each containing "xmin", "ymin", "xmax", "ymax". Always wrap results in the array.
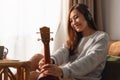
[{"xmin": 0, "ymin": 0, "xmax": 61, "ymax": 60}]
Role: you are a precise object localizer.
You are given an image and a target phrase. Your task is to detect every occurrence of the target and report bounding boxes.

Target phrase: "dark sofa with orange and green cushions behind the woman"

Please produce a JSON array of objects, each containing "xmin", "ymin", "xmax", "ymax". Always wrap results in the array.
[{"xmin": 101, "ymin": 40, "xmax": 120, "ymax": 80}]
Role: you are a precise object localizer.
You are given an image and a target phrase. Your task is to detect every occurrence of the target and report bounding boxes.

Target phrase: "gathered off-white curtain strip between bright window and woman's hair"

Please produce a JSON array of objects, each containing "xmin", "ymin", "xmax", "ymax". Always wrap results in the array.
[{"xmin": 53, "ymin": 0, "xmax": 69, "ymax": 52}]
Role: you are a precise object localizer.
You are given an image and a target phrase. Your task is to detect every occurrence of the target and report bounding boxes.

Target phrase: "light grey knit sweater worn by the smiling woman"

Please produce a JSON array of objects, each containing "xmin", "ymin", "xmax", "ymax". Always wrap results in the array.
[{"xmin": 51, "ymin": 31, "xmax": 109, "ymax": 80}]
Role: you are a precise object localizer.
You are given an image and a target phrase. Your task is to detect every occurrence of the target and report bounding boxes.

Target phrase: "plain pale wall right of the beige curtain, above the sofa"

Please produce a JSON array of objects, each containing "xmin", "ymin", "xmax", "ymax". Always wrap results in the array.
[{"xmin": 102, "ymin": 0, "xmax": 120, "ymax": 40}]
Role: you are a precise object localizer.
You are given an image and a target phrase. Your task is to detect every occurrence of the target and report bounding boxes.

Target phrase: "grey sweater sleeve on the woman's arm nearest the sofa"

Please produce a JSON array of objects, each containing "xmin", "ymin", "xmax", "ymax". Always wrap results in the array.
[{"xmin": 62, "ymin": 32, "xmax": 108, "ymax": 77}]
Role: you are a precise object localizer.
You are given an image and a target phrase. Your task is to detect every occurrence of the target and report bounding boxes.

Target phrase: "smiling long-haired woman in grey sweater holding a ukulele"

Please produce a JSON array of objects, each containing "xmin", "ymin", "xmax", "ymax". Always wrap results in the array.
[{"xmin": 29, "ymin": 4, "xmax": 108, "ymax": 80}]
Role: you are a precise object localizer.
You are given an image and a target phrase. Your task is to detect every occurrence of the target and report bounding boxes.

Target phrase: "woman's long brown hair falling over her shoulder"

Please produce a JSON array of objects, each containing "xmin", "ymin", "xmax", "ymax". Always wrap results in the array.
[{"xmin": 67, "ymin": 4, "xmax": 97, "ymax": 55}]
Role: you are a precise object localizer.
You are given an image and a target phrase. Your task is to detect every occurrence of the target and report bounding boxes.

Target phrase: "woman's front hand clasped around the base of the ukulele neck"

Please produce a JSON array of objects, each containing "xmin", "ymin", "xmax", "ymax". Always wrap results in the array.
[{"xmin": 41, "ymin": 64, "xmax": 62, "ymax": 77}]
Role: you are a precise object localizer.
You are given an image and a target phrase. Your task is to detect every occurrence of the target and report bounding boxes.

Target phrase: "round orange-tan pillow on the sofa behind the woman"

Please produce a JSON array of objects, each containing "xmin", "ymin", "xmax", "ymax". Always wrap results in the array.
[{"xmin": 108, "ymin": 41, "xmax": 120, "ymax": 56}]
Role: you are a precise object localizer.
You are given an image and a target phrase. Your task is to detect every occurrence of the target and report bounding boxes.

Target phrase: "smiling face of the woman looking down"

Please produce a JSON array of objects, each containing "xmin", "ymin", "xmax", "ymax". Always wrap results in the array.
[{"xmin": 70, "ymin": 9, "xmax": 88, "ymax": 32}]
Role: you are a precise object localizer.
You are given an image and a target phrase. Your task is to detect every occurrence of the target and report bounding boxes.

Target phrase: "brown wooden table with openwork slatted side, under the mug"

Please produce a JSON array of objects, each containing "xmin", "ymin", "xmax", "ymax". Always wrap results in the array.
[{"xmin": 0, "ymin": 60, "xmax": 30, "ymax": 80}]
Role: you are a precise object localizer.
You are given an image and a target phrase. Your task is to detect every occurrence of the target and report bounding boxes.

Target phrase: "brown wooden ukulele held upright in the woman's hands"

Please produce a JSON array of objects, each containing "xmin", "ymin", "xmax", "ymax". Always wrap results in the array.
[{"xmin": 38, "ymin": 27, "xmax": 59, "ymax": 80}]
